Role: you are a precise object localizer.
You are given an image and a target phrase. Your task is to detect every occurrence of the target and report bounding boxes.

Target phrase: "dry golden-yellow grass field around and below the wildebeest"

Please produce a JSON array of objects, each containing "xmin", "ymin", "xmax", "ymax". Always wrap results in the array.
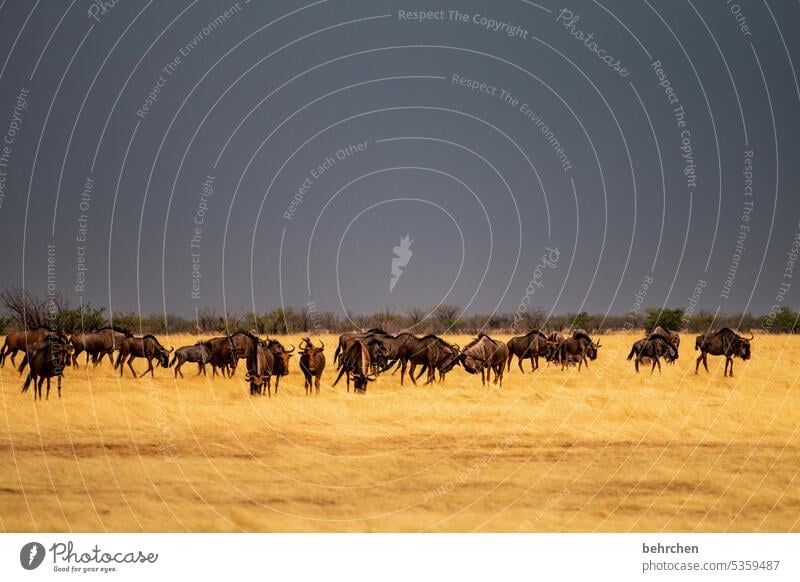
[{"xmin": 0, "ymin": 335, "xmax": 800, "ymax": 532}]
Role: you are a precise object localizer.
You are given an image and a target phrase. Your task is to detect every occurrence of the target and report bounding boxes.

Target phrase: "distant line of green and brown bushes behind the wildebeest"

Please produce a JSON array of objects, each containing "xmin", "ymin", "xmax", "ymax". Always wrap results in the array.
[{"xmin": 0, "ymin": 288, "xmax": 800, "ymax": 335}]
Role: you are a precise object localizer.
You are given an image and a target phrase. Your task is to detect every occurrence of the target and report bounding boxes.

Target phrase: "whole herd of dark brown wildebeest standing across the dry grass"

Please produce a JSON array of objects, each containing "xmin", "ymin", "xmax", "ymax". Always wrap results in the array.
[{"xmin": 0, "ymin": 326, "xmax": 753, "ymax": 400}]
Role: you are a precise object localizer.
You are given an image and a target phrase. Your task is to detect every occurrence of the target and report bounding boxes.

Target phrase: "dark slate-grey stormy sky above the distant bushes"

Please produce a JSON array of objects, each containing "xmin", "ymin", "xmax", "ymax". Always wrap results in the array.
[{"xmin": 0, "ymin": 0, "xmax": 800, "ymax": 322}]
